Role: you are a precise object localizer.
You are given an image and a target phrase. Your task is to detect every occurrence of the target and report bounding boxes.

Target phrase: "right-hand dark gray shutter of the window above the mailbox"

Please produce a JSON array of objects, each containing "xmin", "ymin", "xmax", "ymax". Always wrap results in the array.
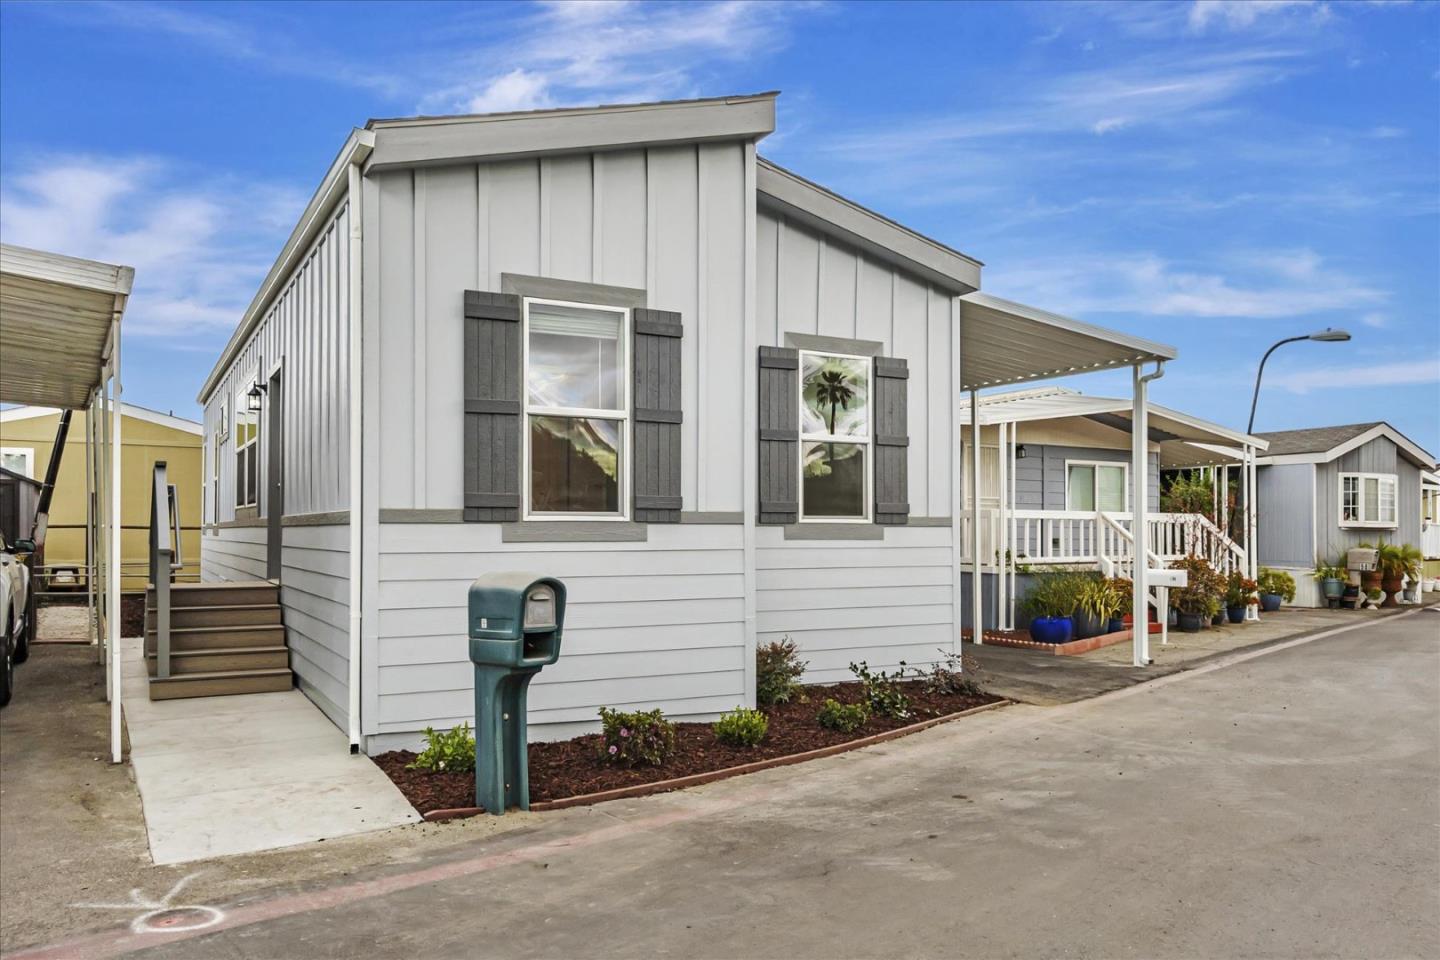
[{"xmin": 631, "ymin": 308, "xmax": 684, "ymax": 524}]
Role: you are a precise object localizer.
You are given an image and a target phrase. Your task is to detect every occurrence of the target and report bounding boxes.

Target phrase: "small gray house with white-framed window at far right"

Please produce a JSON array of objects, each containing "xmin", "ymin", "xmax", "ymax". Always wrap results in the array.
[{"xmin": 1257, "ymin": 423, "xmax": 1436, "ymax": 606}]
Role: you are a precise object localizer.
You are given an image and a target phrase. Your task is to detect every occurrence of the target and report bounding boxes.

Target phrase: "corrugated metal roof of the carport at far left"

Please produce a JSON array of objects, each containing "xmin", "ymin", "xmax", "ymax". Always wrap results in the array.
[{"xmin": 0, "ymin": 243, "xmax": 135, "ymax": 409}]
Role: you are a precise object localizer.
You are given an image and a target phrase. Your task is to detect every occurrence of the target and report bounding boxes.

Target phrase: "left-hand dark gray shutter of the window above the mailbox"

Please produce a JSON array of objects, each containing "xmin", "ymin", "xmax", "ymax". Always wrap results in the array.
[{"xmin": 465, "ymin": 291, "xmax": 523, "ymax": 522}]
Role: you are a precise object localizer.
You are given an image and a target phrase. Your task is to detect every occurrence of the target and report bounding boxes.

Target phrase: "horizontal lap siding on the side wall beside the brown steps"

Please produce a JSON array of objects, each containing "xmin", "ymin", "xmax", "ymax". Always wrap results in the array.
[{"xmin": 279, "ymin": 525, "xmax": 350, "ymax": 730}]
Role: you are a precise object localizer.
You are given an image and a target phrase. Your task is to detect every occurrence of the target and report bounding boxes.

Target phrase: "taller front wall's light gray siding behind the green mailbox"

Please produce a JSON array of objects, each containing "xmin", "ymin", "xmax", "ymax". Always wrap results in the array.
[{"xmin": 363, "ymin": 142, "xmax": 753, "ymax": 753}]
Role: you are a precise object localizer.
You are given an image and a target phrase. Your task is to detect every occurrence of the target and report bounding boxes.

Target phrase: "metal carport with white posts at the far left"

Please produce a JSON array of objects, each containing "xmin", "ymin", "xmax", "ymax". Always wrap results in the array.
[{"xmin": 0, "ymin": 243, "xmax": 135, "ymax": 763}]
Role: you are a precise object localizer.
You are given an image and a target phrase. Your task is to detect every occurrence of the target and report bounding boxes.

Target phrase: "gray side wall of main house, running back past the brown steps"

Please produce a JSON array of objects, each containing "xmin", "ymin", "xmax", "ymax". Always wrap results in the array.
[{"xmin": 200, "ymin": 203, "xmax": 350, "ymax": 728}]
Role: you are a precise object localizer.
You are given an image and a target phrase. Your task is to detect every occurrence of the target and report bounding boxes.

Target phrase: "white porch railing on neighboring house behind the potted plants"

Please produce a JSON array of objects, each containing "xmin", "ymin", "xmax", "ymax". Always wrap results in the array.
[{"xmin": 960, "ymin": 510, "xmax": 1246, "ymax": 576}]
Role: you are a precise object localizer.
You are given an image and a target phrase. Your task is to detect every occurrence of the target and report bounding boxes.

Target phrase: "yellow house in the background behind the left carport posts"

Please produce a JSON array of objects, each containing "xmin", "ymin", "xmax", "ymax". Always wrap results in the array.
[{"xmin": 0, "ymin": 403, "xmax": 202, "ymax": 592}]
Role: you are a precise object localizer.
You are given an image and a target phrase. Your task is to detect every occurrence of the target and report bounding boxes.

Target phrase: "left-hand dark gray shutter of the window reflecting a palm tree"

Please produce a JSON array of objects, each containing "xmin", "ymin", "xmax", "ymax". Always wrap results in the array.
[{"xmin": 757, "ymin": 347, "xmax": 801, "ymax": 524}]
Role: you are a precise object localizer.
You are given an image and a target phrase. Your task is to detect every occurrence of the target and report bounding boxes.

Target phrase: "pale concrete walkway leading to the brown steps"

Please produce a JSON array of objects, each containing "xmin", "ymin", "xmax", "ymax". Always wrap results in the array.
[{"xmin": 122, "ymin": 638, "xmax": 419, "ymax": 864}]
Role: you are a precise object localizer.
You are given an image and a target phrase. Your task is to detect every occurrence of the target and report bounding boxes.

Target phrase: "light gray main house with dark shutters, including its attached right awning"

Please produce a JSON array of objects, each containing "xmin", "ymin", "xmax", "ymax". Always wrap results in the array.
[{"xmin": 200, "ymin": 95, "xmax": 1175, "ymax": 753}]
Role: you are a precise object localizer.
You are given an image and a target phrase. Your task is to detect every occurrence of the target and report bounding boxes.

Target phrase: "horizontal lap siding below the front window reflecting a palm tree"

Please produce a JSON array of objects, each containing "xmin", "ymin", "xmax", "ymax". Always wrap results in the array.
[{"xmin": 756, "ymin": 527, "xmax": 953, "ymax": 684}]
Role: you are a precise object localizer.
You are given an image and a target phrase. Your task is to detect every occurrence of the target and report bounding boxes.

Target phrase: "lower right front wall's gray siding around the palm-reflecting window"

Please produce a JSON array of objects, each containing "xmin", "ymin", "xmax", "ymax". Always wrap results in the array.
[{"xmin": 750, "ymin": 206, "xmax": 955, "ymax": 684}]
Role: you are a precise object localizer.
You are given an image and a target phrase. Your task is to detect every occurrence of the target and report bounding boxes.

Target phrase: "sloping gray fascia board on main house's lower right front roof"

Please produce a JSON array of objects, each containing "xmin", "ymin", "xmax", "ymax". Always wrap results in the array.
[{"xmin": 756, "ymin": 158, "xmax": 984, "ymax": 295}]
